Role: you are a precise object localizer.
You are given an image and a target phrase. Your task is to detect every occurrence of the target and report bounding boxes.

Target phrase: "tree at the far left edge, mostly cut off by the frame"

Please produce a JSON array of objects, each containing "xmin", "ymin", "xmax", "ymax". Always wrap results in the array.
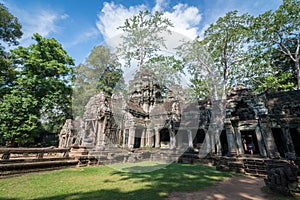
[{"xmin": 0, "ymin": 3, "xmax": 22, "ymax": 99}]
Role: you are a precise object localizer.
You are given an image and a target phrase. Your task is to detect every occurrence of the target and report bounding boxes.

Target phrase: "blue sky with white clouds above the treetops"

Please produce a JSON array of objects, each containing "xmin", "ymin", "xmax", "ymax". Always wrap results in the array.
[{"xmin": 0, "ymin": 0, "xmax": 282, "ymax": 65}]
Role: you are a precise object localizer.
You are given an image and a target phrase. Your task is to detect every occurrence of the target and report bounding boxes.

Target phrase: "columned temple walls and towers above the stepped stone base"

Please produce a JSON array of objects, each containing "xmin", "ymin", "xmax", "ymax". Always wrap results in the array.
[{"xmin": 59, "ymin": 70, "xmax": 300, "ymax": 158}]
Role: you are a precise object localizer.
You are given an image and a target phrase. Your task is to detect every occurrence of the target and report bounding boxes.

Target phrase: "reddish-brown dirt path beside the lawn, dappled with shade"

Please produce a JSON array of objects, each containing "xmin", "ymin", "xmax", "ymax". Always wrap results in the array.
[{"xmin": 167, "ymin": 177, "xmax": 269, "ymax": 200}]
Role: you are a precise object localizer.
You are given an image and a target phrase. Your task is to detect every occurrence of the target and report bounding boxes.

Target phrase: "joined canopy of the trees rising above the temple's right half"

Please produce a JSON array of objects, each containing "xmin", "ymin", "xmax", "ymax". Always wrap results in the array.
[{"xmin": 178, "ymin": 0, "xmax": 300, "ymax": 99}]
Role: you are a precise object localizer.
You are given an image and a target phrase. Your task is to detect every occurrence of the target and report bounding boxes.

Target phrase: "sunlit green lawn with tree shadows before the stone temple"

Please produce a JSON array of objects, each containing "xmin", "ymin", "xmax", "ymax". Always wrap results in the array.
[{"xmin": 0, "ymin": 162, "xmax": 233, "ymax": 200}]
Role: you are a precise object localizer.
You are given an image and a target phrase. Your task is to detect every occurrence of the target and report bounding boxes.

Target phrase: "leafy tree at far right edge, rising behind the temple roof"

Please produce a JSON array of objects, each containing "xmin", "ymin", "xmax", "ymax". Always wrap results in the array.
[{"xmin": 251, "ymin": 0, "xmax": 300, "ymax": 89}]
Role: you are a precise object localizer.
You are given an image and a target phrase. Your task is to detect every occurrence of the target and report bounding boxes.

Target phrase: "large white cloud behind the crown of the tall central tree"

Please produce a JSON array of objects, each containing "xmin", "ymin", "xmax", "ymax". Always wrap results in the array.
[{"xmin": 96, "ymin": 0, "xmax": 201, "ymax": 48}]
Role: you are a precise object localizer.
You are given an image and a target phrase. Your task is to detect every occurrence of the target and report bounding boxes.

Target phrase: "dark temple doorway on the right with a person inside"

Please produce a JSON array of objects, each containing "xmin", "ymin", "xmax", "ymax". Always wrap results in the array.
[{"xmin": 241, "ymin": 130, "xmax": 259, "ymax": 154}]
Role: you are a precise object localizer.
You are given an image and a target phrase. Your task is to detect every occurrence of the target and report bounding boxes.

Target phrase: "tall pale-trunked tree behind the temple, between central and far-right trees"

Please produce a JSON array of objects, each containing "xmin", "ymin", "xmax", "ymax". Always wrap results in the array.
[{"xmin": 178, "ymin": 11, "xmax": 250, "ymax": 99}]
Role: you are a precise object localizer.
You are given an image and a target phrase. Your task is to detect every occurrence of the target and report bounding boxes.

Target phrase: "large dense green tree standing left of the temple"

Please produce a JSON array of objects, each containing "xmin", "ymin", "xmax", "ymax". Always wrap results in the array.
[{"xmin": 0, "ymin": 34, "xmax": 74, "ymax": 144}]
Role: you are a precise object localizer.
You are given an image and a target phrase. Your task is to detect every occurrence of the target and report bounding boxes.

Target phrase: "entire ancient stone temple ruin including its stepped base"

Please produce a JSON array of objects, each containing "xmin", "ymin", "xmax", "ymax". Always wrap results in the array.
[{"xmin": 59, "ymin": 70, "xmax": 300, "ymax": 195}]
